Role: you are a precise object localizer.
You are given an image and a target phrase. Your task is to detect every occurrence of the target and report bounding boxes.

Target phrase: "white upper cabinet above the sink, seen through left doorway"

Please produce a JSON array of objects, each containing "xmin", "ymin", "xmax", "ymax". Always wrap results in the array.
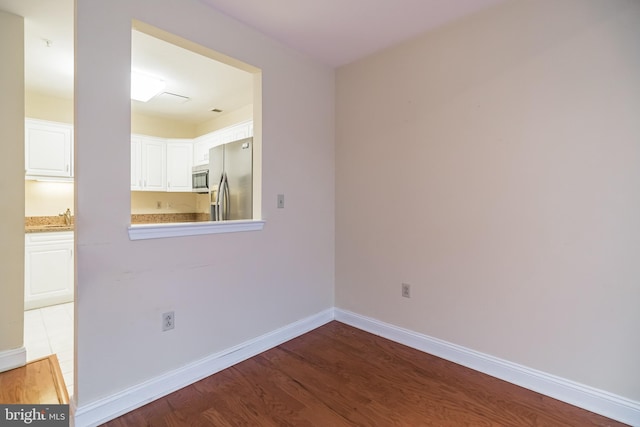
[{"xmin": 25, "ymin": 119, "xmax": 73, "ymax": 177}]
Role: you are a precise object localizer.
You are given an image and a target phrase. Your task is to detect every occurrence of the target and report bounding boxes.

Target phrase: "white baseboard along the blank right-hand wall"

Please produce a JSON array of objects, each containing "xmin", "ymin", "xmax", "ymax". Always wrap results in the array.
[{"xmin": 335, "ymin": 308, "xmax": 640, "ymax": 426}]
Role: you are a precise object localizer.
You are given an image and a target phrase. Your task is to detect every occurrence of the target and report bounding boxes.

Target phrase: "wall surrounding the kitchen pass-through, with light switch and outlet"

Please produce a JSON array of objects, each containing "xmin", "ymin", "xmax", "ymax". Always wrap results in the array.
[{"xmin": 75, "ymin": 0, "xmax": 334, "ymax": 411}]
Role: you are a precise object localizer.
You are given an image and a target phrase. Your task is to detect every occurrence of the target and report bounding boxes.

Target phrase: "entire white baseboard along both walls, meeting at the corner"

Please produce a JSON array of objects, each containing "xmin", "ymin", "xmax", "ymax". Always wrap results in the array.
[{"xmin": 69, "ymin": 308, "xmax": 640, "ymax": 427}]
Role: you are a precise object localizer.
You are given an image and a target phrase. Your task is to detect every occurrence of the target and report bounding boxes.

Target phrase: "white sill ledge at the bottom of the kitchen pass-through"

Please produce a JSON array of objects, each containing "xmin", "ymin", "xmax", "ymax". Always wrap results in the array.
[{"xmin": 128, "ymin": 220, "xmax": 265, "ymax": 240}]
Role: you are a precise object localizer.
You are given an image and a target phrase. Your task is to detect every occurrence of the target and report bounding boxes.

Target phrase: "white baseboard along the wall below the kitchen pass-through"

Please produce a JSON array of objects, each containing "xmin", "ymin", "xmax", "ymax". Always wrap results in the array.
[{"xmin": 71, "ymin": 309, "xmax": 333, "ymax": 427}]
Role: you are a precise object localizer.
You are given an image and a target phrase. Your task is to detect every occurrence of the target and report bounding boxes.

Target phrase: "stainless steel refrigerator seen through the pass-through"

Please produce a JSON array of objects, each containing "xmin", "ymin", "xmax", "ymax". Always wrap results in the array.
[{"xmin": 209, "ymin": 138, "xmax": 253, "ymax": 221}]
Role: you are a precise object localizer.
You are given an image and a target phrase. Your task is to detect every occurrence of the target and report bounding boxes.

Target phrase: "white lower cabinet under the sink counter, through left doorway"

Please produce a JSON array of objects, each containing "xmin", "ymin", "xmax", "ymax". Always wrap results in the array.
[{"xmin": 24, "ymin": 231, "xmax": 74, "ymax": 310}]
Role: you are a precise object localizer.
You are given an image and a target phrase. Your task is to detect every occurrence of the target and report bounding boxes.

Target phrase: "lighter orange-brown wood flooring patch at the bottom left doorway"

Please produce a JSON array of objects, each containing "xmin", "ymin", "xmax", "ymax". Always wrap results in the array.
[{"xmin": 0, "ymin": 354, "xmax": 69, "ymax": 404}]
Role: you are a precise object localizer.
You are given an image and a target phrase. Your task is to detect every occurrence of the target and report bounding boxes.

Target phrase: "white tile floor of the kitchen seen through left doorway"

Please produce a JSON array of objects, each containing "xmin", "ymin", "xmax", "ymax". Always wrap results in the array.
[{"xmin": 24, "ymin": 302, "xmax": 73, "ymax": 396}]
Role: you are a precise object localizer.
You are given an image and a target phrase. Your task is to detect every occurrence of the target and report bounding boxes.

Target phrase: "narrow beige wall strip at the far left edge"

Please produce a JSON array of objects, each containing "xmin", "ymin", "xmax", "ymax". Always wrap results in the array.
[{"xmin": 0, "ymin": 11, "xmax": 24, "ymax": 364}]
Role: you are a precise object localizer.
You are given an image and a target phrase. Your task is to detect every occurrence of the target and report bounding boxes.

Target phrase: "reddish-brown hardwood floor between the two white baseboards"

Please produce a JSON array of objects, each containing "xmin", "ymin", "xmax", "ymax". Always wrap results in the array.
[{"xmin": 106, "ymin": 321, "xmax": 624, "ymax": 427}]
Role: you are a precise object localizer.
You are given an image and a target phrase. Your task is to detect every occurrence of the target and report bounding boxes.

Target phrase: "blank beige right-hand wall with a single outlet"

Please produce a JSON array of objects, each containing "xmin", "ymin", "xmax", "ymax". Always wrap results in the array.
[{"xmin": 336, "ymin": 0, "xmax": 640, "ymax": 401}]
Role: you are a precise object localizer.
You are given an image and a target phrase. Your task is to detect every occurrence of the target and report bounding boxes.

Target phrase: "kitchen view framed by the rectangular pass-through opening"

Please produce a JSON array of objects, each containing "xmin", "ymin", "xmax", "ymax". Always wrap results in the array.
[{"xmin": 130, "ymin": 21, "xmax": 261, "ymax": 232}]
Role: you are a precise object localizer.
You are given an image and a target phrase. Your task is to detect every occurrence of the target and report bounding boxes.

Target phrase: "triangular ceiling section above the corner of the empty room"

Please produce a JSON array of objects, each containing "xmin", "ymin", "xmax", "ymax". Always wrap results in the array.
[{"xmin": 200, "ymin": 0, "xmax": 503, "ymax": 67}]
